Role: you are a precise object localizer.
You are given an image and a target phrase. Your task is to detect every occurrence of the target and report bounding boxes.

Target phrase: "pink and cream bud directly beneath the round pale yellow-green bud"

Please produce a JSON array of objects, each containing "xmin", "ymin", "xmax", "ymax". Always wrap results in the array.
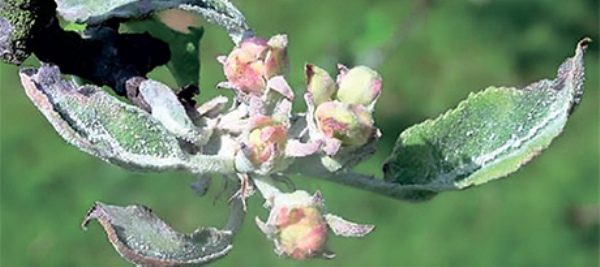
[{"xmin": 315, "ymin": 101, "xmax": 374, "ymax": 147}]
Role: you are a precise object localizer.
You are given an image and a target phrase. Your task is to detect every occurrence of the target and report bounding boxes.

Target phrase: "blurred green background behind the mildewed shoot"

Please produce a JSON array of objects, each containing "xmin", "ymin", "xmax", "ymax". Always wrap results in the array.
[{"xmin": 0, "ymin": 0, "xmax": 600, "ymax": 267}]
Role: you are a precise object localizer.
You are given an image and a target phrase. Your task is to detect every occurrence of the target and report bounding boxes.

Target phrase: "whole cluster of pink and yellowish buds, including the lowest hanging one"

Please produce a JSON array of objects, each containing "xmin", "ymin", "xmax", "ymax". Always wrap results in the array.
[{"xmin": 220, "ymin": 35, "xmax": 382, "ymax": 260}]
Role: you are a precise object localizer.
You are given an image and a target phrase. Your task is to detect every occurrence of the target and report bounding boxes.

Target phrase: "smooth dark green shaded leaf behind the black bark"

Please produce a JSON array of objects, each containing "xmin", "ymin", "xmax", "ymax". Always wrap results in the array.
[{"xmin": 127, "ymin": 18, "xmax": 204, "ymax": 87}]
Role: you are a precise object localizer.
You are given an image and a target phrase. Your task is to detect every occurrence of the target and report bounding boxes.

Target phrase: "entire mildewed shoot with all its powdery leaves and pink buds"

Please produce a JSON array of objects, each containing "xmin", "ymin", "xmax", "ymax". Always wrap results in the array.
[{"xmin": 0, "ymin": 1, "xmax": 589, "ymax": 266}]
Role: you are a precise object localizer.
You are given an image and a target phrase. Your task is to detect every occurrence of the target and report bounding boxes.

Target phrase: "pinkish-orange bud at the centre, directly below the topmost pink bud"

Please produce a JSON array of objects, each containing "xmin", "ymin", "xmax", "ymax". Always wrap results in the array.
[{"xmin": 248, "ymin": 116, "xmax": 287, "ymax": 165}]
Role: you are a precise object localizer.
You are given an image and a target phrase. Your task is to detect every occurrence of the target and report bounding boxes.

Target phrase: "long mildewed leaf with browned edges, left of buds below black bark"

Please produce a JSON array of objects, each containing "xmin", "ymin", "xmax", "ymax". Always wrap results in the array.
[{"xmin": 20, "ymin": 65, "xmax": 187, "ymax": 172}]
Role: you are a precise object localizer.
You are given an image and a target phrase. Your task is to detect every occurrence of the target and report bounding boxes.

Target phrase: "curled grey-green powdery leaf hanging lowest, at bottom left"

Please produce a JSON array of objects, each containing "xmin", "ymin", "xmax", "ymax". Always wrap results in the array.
[{"xmin": 82, "ymin": 202, "xmax": 232, "ymax": 267}]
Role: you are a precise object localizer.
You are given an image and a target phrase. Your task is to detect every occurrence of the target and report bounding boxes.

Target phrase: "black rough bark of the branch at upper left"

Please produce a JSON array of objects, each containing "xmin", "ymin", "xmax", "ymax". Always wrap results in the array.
[{"xmin": 0, "ymin": 0, "xmax": 171, "ymax": 96}]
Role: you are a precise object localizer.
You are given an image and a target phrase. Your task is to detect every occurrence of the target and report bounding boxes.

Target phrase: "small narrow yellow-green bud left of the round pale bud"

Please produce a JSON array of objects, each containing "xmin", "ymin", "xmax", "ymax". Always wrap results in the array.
[{"xmin": 304, "ymin": 64, "xmax": 336, "ymax": 105}]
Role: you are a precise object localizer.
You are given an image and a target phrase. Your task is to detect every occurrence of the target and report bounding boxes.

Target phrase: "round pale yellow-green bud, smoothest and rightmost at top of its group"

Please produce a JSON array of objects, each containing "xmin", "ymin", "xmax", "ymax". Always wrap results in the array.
[{"xmin": 337, "ymin": 66, "xmax": 382, "ymax": 106}]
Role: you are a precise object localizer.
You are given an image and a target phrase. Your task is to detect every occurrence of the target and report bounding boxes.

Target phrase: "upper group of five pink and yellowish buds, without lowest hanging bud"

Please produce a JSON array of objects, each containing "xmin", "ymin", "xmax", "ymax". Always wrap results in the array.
[{"xmin": 219, "ymin": 35, "xmax": 382, "ymax": 175}]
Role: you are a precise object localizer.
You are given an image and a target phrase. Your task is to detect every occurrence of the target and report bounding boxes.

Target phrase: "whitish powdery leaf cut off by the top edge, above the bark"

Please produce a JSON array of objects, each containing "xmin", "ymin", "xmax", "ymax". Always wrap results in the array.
[{"xmin": 55, "ymin": 0, "xmax": 250, "ymax": 43}]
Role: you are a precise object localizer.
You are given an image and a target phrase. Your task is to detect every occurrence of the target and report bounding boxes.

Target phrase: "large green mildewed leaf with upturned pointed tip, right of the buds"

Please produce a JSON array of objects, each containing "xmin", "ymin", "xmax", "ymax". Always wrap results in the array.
[{"xmin": 383, "ymin": 38, "xmax": 591, "ymax": 200}]
